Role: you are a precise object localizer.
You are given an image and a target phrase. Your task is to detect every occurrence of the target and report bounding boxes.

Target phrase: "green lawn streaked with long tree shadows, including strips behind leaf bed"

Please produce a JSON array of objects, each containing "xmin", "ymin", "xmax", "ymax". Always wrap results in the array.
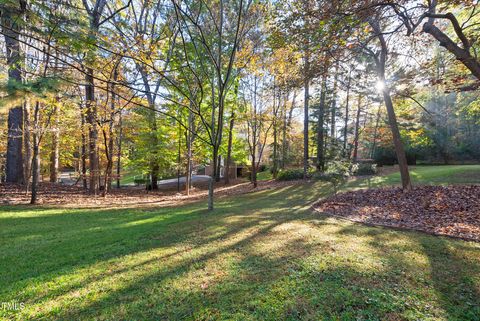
[{"xmin": 0, "ymin": 166, "xmax": 480, "ymax": 320}]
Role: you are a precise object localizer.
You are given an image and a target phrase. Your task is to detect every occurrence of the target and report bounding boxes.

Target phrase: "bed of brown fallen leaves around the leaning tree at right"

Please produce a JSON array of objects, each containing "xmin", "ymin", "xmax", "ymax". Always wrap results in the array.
[{"xmin": 314, "ymin": 185, "xmax": 480, "ymax": 241}]
